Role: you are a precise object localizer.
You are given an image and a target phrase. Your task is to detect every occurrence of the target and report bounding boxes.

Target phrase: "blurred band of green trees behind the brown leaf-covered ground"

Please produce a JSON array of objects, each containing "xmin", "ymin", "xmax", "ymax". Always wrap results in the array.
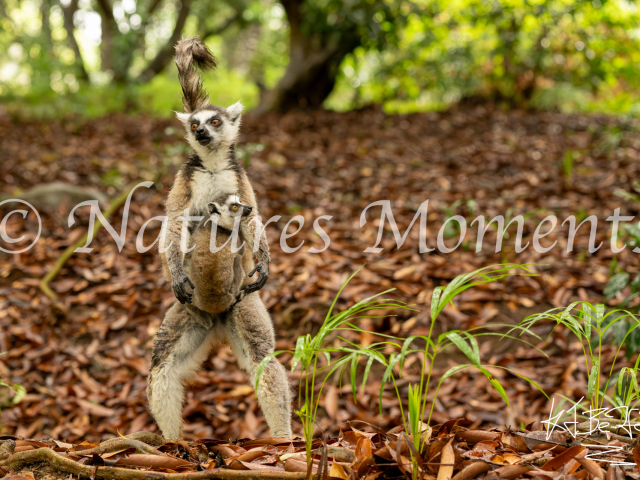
[{"xmin": 0, "ymin": 0, "xmax": 640, "ymax": 118}]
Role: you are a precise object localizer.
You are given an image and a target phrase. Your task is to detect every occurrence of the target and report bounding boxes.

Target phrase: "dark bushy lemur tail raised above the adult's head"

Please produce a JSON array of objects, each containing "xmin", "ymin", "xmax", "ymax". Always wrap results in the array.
[{"xmin": 176, "ymin": 37, "xmax": 216, "ymax": 113}]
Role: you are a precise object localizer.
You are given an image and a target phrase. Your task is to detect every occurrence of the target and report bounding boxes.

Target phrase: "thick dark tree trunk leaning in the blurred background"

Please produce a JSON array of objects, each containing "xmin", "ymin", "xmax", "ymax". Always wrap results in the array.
[{"xmin": 255, "ymin": 0, "xmax": 360, "ymax": 115}]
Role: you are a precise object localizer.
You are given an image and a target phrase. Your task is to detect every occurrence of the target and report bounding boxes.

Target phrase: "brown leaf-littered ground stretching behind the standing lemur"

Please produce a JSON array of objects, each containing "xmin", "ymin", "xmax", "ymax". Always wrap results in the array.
[{"xmin": 0, "ymin": 107, "xmax": 640, "ymax": 455}]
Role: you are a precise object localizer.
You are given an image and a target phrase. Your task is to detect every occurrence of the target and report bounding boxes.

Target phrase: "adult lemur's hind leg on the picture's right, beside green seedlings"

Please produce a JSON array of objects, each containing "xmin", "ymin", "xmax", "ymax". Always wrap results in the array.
[{"xmin": 224, "ymin": 293, "xmax": 291, "ymax": 438}]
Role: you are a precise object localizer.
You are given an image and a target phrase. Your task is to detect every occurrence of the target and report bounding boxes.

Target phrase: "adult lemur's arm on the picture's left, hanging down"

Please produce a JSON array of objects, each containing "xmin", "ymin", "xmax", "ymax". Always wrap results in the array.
[{"xmin": 165, "ymin": 171, "xmax": 195, "ymax": 304}]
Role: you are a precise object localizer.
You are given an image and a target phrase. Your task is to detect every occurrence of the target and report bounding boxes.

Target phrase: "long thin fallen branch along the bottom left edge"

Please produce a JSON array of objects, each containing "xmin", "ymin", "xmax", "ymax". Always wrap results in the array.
[{"xmin": 0, "ymin": 448, "xmax": 305, "ymax": 480}]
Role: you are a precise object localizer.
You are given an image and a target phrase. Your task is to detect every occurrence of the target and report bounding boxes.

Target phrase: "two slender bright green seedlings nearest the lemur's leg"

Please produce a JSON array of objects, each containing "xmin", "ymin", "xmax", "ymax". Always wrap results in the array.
[{"xmin": 255, "ymin": 265, "xmax": 546, "ymax": 478}]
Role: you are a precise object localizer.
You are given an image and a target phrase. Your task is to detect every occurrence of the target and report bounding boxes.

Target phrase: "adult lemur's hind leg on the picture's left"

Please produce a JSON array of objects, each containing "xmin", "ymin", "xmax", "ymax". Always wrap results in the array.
[{"xmin": 147, "ymin": 303, "xmax": 216, "ymax": 440}]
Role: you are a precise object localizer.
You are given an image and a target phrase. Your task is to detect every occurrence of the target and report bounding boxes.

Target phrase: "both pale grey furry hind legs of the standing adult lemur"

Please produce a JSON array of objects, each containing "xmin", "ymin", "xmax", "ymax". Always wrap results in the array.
[{"xmin": 147, "ymin": 292, "xmax": 291, "ymax": 440}]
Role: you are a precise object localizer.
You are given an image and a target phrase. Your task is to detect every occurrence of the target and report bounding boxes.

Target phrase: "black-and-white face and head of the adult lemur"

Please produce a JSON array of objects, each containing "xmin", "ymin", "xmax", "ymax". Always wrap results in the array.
[{"xmin": 176, "ymin": 102, "xmax": 243, "ymax": 154}]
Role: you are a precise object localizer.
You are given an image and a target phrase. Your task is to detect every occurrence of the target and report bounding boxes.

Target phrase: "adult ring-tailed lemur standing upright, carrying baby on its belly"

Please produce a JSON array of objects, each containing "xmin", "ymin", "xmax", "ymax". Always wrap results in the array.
[{"xmin": 147, "ymin": 37, "xmax": 291, "ymax": 439}]
